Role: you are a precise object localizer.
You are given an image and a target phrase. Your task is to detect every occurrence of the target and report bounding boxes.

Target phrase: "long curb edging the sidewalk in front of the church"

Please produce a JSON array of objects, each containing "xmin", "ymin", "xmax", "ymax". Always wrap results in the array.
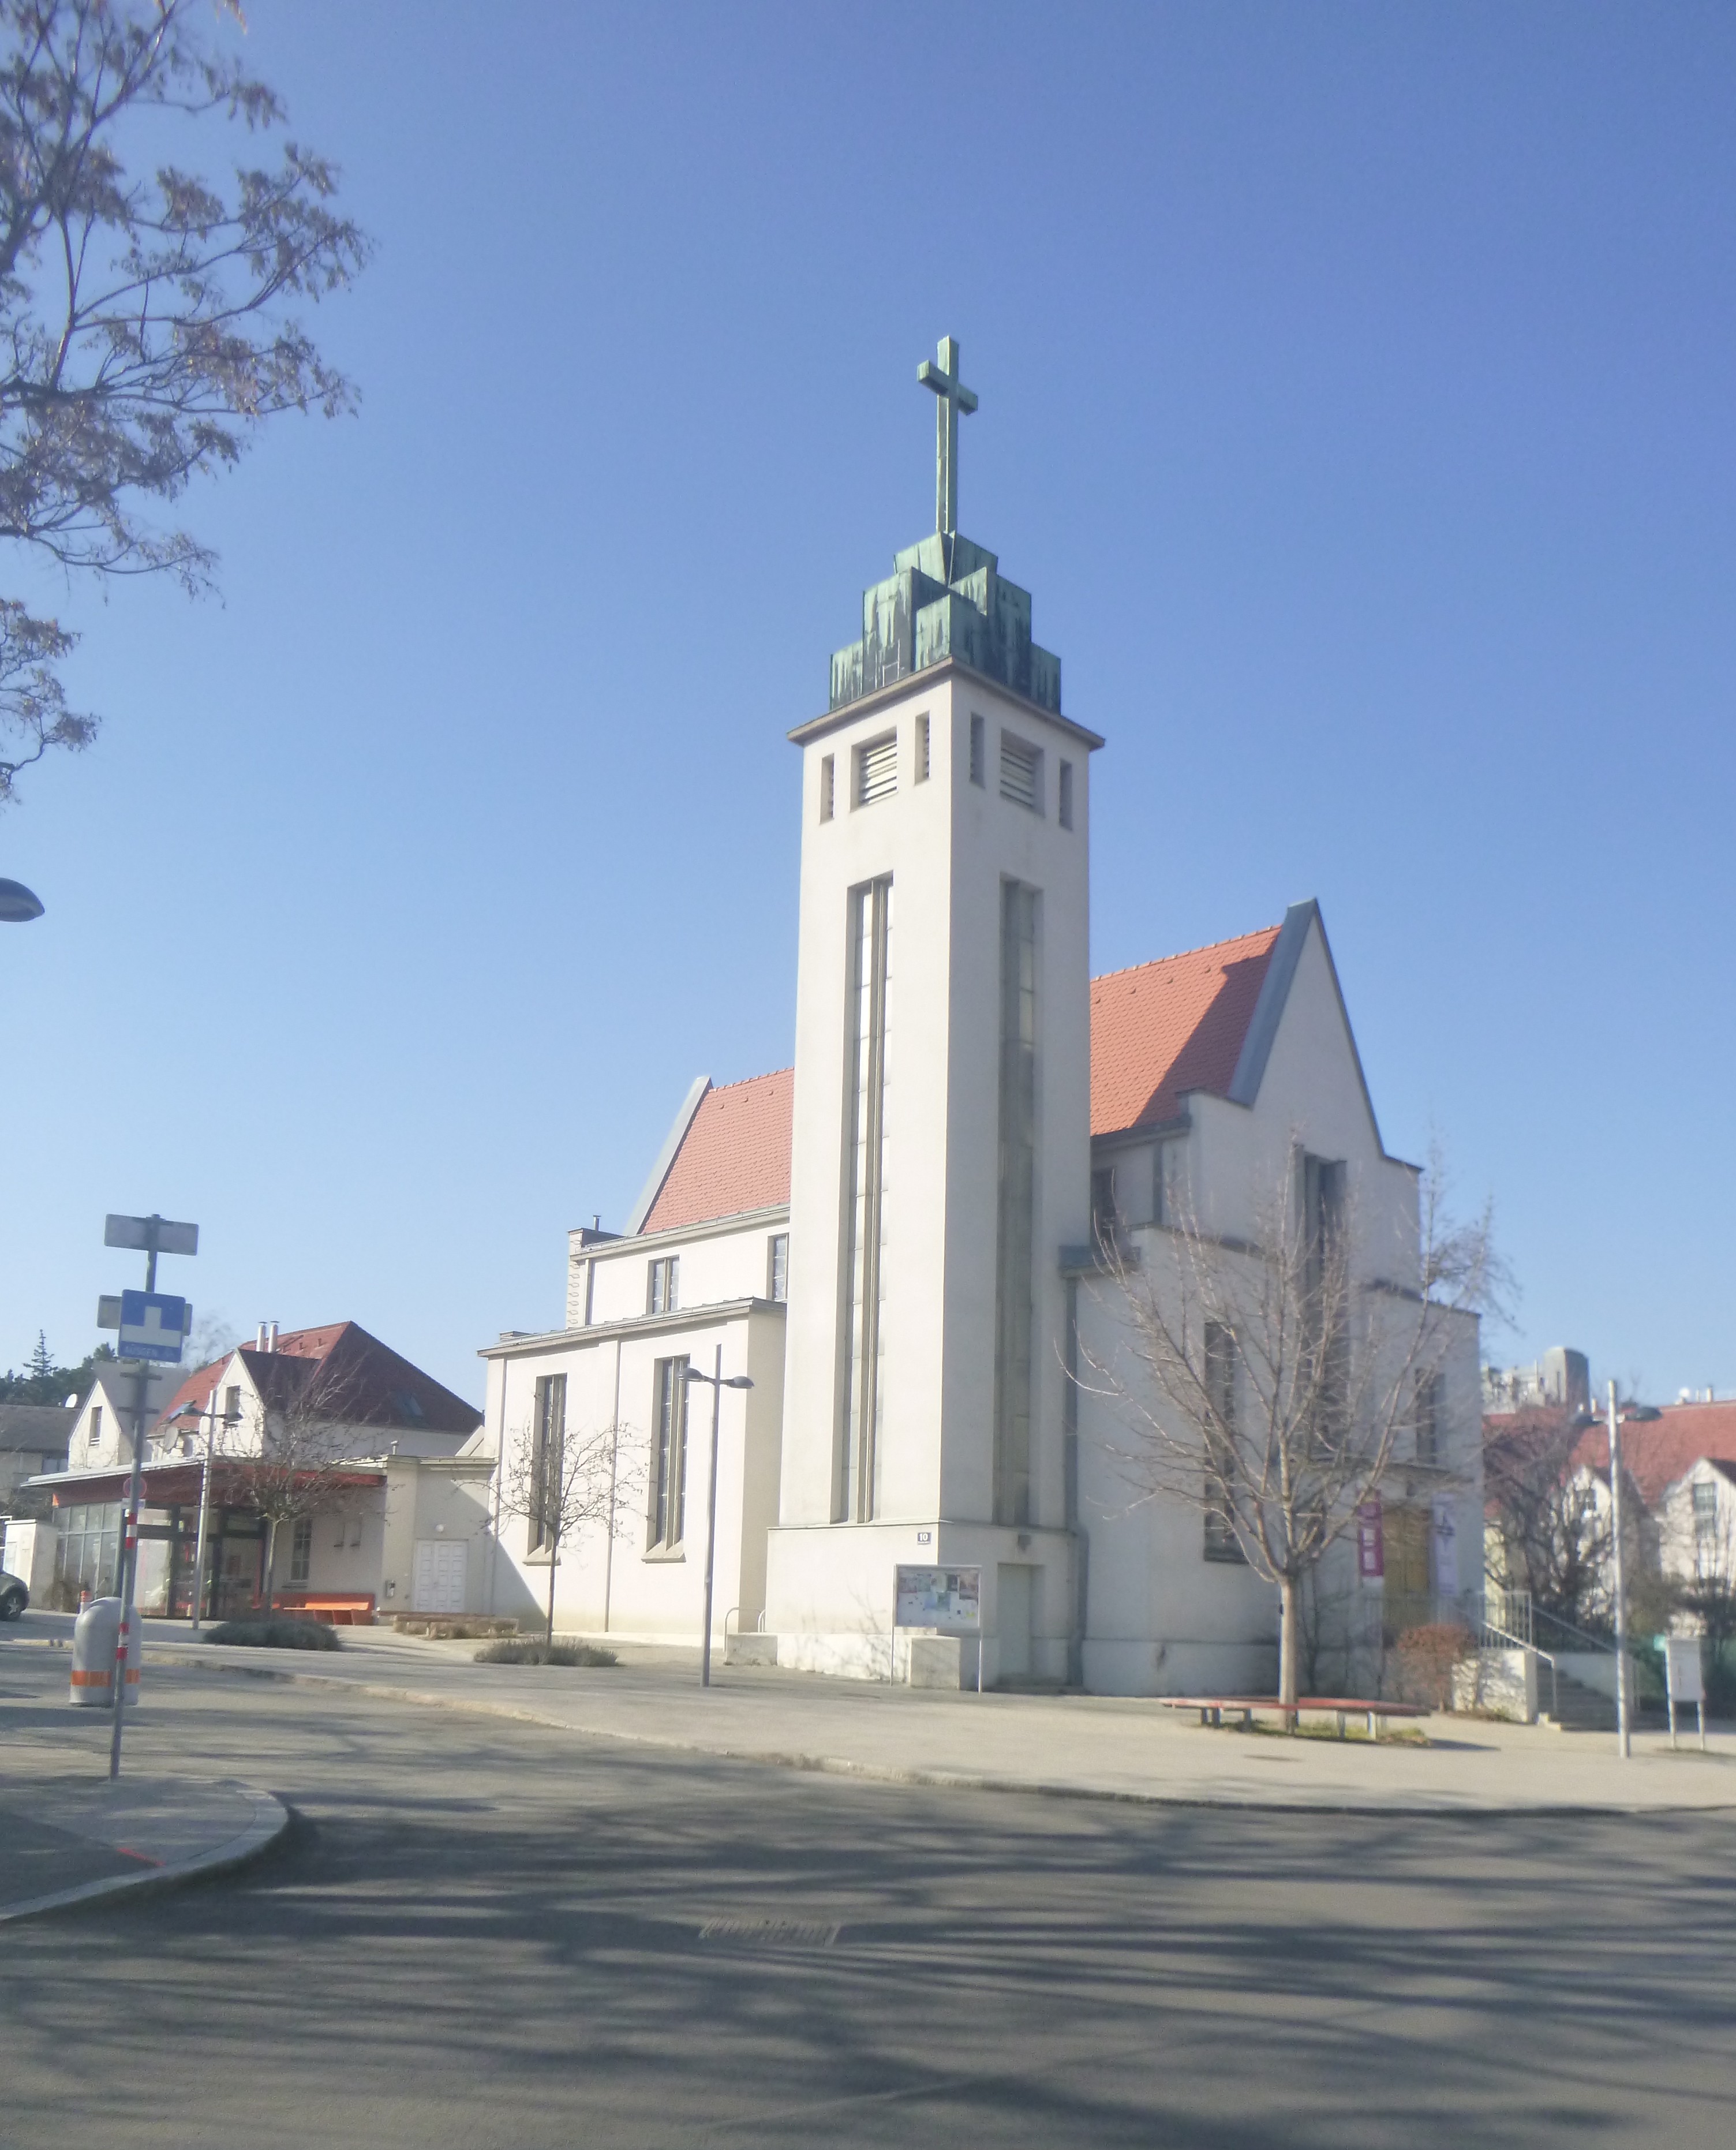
[{"xmin": 146, "ymin": 1649, "xmax": 1736, "ymax": 1821}]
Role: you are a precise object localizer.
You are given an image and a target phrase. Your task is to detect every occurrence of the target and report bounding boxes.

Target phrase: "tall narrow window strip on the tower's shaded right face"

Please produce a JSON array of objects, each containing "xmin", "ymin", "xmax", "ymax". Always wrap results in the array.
[{"xmin": 995, "ymin": 881, "xmax": 1038, "ymax": 1522}]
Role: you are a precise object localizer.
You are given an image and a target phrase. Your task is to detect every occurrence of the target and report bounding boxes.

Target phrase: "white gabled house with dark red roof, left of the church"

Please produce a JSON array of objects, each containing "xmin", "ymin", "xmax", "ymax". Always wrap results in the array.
[{"xmin": 35, "ymin": 1322, "xmax": 494, "ymax": 1619}]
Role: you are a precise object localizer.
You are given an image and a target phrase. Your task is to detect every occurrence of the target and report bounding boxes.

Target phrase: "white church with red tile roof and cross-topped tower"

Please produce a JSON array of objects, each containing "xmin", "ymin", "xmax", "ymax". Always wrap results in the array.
[{"xmin": 479, "ymin": 342, "xmax": 1483, "ymax": 1694}]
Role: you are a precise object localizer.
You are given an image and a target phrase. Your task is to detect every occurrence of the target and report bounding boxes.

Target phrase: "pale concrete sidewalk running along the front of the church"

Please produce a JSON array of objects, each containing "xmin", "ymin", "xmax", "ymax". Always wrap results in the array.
[{"xmin": 85, "ymin": 1621, "xmax": 1736, "ymax": 1812}]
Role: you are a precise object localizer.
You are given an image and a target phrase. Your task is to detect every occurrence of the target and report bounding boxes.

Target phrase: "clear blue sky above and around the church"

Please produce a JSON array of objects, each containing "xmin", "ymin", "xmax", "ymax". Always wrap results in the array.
[{"xmin": 0, "ymin": 0, "xmax": 1736, "ymax": 1396}]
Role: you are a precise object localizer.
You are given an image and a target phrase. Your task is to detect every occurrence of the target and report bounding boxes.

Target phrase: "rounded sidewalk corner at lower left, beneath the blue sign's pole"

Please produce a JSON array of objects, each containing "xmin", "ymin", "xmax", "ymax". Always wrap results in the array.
[{"xmin": 0, "ymin": 1754, "xmax": 290, "ymax": 1924}]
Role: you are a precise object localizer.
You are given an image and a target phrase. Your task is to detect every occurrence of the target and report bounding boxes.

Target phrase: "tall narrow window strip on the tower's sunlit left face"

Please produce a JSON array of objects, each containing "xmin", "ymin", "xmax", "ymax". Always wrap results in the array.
[{"xmin": 832, "ymin": 875, "xmax": 892, "ymax": 1522}]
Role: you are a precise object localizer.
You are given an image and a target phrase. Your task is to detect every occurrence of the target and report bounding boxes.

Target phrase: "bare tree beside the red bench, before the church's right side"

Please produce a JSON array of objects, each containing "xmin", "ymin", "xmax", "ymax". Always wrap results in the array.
[{"xmin": 1091, "ymin": 1144, "xmax": 1504, "ymax": 1703}]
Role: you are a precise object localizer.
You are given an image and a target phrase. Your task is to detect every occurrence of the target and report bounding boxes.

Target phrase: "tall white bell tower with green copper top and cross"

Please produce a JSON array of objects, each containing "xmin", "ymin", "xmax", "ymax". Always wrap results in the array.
[{"xmin": 767, "ymin": 338, "xmax": 1102, "ymax": 1679}]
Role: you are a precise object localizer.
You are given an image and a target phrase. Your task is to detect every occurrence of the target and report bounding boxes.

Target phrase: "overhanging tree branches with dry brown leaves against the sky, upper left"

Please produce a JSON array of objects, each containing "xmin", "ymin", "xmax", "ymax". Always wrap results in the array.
[{"xmin": 0, "ymin": 0, "xmax": 368, "ymax": 804}]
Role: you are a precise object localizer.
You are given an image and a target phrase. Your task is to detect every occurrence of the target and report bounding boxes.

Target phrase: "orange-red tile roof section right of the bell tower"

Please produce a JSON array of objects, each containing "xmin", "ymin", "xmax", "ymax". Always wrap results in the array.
[{"xmin": 1091, "ymin": 926, "xmax": 1281, "ymax": 1135}]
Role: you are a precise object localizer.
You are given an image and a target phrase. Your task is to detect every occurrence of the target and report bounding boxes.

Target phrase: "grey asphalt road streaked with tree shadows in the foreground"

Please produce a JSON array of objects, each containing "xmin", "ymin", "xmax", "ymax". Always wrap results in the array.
[{"xmin": 0, "ymin": 1654, "xmax": 1736, "ymax": 2150}]
